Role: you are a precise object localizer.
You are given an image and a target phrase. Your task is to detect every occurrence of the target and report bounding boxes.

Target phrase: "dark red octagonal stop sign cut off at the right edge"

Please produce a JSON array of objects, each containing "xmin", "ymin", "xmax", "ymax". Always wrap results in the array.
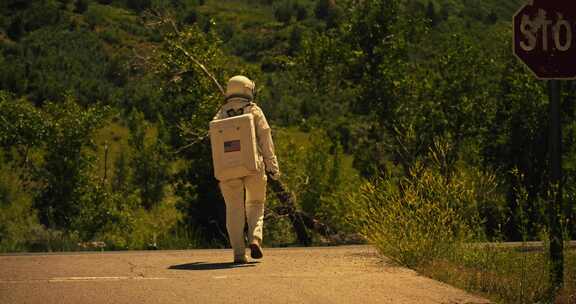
[{"xmin": 513, "ymin": 0, "xmax": 576, "ymax": 79}]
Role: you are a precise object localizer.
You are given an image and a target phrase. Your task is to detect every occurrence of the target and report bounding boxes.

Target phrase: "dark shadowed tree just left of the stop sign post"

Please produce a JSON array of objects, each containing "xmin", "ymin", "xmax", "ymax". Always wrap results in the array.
[{"xmin": 482, "ymin": 54, "xmax": 548, "ymax": 241}]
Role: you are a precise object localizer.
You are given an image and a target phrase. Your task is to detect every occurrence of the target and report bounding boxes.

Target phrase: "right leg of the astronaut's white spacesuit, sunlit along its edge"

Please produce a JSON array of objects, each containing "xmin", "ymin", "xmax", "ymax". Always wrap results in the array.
[{"xmin": 244, "ymin": 172, "xmax": 267, "ymax": 244}]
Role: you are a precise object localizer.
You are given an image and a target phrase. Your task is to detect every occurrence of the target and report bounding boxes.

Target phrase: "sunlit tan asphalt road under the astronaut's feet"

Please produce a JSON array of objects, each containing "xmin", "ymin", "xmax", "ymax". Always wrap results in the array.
[{"xmin": 0, "ymin": 246, "xmax": 488, "ymax": 304}]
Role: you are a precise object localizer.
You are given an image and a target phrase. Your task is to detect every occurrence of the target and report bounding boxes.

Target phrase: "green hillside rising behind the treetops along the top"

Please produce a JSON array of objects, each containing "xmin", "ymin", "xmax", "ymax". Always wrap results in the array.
[{"xmin": 0, "ymin": 0, "xmax": 521, "ymax": 109}]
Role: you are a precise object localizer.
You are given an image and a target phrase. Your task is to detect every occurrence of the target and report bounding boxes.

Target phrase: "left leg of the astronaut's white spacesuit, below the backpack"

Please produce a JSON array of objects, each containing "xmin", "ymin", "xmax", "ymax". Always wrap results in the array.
[{"xmin": 220, "ymin": 179, "xmax": 246, "ymax": 257}]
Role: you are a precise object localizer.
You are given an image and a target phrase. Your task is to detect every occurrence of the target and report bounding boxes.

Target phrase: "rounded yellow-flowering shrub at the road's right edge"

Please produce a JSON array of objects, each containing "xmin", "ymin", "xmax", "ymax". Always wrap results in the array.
[{"xmin": 353, "ymin": 140, "xmax": 503, "ymax": 267}]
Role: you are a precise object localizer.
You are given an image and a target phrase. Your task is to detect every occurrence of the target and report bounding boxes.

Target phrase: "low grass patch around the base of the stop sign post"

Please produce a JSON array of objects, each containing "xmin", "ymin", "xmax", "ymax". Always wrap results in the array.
[{"xmin": 417, "ymin": 246, "xmax": 576, "ymax": 303}]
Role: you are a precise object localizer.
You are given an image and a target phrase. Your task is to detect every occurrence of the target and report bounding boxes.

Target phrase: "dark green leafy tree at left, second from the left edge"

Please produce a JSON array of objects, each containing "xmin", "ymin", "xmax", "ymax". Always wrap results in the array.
[{"xmin": 35, "ymin": 98, "xmax": 105, "ymax": 229}]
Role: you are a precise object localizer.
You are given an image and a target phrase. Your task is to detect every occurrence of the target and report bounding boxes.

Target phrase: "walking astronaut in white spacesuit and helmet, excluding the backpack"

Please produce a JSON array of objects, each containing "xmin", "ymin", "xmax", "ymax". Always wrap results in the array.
[{"xmin": 214, "ymin": 75, "xmax": 280, "ymax": 264}]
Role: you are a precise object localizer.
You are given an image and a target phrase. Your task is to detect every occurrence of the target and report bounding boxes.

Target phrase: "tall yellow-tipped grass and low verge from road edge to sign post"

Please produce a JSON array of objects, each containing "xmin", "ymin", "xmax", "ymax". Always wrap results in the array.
[{"xmin": 352, "ymin": 145, "xmax": 576, "ymax": 303}]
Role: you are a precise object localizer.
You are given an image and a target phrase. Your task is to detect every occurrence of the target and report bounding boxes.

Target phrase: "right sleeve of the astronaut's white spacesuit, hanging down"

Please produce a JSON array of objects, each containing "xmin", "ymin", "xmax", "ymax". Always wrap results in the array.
[{"xmin": 252, "ymin": 106, "xmax": 280, "ymax": 174}]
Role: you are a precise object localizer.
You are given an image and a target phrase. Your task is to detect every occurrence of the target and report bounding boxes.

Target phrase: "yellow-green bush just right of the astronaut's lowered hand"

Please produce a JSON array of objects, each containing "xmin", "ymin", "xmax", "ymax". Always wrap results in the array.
[{"xmin": 274, "ymin": 129, "xmax": 361, "ymax": 233}]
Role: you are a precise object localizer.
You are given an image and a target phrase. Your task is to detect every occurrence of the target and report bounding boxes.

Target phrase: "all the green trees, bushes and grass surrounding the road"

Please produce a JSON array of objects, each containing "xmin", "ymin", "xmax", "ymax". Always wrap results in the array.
[{"xmin": 0, "ymin": 0, "xmax": 576, "ymax": 303}]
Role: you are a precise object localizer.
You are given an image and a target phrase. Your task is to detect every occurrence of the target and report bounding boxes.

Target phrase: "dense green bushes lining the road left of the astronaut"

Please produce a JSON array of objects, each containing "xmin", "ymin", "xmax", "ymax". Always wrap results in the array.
[{"xmin": 0, "ymin": 94, "xmax": 194, "ymax": 251}]
